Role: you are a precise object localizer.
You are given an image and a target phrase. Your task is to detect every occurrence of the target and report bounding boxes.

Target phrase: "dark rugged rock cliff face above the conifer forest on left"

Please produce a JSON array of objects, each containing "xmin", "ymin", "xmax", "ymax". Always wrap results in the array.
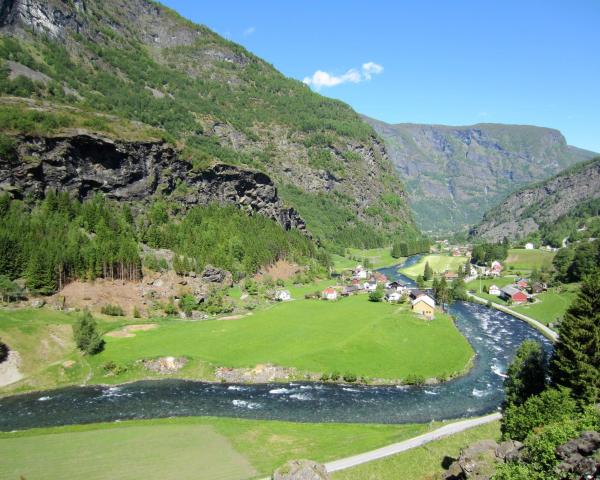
[{"xmin": 0, "ymin": 134, "xmax": 305, "ymax": 231}]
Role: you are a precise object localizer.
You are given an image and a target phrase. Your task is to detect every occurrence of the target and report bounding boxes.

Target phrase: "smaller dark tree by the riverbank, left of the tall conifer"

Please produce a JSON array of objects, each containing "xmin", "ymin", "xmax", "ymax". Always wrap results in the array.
[{"xmin": 502, "ymin": 340, "xmax": 546, "ymax": 410}]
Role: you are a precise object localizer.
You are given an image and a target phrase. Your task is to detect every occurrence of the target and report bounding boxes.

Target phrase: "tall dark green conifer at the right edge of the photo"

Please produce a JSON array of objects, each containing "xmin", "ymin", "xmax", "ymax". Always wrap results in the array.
[{"xmin": 552, "ymin": 270, "xmax": 600, "ymax": 403}]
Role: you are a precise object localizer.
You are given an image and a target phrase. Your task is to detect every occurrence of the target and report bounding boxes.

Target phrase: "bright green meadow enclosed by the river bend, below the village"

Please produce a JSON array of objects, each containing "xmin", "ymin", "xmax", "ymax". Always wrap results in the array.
[{"xmin": 89, "ymin": 295, "xmax": 473, "ymax": 382}]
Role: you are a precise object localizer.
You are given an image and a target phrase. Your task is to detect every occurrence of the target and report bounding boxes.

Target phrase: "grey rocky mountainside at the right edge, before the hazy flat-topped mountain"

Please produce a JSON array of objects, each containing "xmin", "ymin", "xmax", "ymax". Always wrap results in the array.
[{"xmin": 471, "ymin": 157, "xmax": 600, "ymax": 246}]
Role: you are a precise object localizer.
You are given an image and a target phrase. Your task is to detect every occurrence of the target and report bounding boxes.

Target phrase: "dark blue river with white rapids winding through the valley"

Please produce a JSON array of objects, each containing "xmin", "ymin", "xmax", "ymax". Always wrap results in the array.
[{"xmin": 0, "ymin": 256, "xmax": 552, "ymax": 431}]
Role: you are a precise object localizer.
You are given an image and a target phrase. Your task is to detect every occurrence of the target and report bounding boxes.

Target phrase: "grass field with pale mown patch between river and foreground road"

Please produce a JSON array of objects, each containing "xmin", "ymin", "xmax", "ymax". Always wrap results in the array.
[{"xmin": 0, "ymin": 417, "xmax": 438, "ymax": 480}]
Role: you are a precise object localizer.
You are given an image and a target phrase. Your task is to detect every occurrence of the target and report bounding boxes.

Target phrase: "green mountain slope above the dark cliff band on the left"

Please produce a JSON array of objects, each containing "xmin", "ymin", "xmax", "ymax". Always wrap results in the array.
[{"xmin": 0, "ymin": 0, "xmax": 418, "ymax": 251}]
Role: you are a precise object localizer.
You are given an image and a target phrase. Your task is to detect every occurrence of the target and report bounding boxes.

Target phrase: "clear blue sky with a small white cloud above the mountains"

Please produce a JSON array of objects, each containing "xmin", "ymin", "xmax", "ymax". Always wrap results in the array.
[{"xmin": 163, "ymin": 0, "xmax": 600, "ymax": 152}]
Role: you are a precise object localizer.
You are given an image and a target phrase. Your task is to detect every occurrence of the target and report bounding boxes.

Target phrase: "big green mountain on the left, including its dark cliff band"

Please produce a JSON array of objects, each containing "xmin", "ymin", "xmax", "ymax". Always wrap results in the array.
[{"xmin": 0, "ymin": 0, "xmax": 420, "ymax": 249}]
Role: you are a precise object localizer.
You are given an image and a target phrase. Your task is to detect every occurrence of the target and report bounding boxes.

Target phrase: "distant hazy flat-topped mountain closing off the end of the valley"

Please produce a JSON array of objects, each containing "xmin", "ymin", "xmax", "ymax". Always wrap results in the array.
[{"xmin": 363, "ymin": 117, "xmax": 594, "ymax": 234}]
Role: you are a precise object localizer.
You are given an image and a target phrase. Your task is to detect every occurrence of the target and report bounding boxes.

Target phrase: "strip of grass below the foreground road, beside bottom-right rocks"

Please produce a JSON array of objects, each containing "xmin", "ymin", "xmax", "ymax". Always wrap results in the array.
[{"xmin": 332, "ymin": 422, "xmax": 500, "ymax": 480}]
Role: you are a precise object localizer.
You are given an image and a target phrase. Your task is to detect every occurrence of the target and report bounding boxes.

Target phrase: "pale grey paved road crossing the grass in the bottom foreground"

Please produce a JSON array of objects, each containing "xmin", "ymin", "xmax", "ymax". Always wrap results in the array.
[{"xmin": 325, "ymin": 413, "xmax": 501, "ymax": 472}]
